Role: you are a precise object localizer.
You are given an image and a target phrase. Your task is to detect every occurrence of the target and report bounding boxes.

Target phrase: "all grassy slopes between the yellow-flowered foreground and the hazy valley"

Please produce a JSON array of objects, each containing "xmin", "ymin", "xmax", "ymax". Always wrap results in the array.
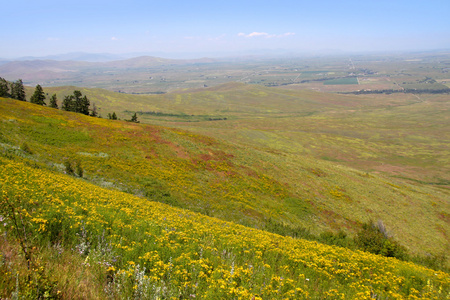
[{"xmin": 0, "ymin": 89, "xmax": 449, "ymax": 254}]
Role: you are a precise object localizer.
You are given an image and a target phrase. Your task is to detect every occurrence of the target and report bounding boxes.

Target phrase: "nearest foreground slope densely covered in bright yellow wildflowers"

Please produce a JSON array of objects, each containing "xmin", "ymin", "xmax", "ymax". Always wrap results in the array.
[{"xmin": 0, "ymin": 157, "xmax": 450, "ymax": 299}]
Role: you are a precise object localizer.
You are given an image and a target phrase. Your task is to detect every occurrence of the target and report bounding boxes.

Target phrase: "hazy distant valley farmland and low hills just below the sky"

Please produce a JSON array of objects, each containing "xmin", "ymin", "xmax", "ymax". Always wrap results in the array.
[{"xmin": 0, "ymin": 52, "xmax": 450, "ymax": 94}]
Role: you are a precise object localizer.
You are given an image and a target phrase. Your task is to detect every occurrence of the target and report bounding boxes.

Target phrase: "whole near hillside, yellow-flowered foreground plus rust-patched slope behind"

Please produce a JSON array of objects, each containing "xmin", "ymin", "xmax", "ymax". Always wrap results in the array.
[{"xmin": 0, "ymin": 99, "xmax": 450, "ymax": 299}]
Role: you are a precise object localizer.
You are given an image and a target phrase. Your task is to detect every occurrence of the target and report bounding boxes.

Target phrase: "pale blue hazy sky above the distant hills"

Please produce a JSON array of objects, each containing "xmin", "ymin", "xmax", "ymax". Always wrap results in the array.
[{"xmin": 0, "ymin": 0, "xmax": 450, "ymax": 59}]
